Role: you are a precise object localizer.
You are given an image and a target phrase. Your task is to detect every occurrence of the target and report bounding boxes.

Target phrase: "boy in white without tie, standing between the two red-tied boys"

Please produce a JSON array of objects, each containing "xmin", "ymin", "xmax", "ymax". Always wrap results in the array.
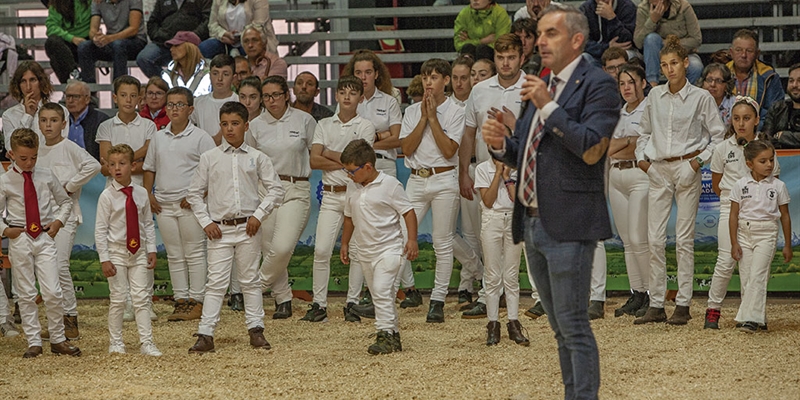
[{"xmin": 39, "ymin": 103, "xmax": 100, "ymax": 340}]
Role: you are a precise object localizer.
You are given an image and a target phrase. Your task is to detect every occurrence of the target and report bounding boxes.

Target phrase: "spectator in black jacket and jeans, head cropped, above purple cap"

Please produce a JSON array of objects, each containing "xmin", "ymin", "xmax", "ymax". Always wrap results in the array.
[{"xmin": 136, "ymin": 0, "xmax": 211, "ymax": 78}]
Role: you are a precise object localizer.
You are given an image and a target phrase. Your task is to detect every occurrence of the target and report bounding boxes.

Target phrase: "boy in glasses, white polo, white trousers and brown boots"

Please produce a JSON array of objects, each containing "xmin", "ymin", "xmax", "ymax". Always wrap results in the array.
[{"xmin": 143, "ymin": 86, "xmax": 214, "ymax": 321}]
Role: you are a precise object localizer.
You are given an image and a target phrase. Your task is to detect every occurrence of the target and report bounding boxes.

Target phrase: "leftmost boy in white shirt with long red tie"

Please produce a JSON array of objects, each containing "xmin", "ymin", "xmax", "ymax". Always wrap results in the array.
[{"xmin": 0, "ymin": 128, "xmax": 81, "ymax": 358}]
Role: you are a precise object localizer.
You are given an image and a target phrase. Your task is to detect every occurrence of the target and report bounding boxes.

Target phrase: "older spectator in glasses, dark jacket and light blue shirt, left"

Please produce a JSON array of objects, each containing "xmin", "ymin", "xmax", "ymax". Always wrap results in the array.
[{"xmin": 64, "ymin": 80, "xmax": 109, "ymax": 161}]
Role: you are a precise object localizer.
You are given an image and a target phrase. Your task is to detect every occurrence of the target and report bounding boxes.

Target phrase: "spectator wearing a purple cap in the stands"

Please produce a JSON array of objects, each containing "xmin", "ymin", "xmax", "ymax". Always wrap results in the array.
[{"xmin": 161, "ymin": 31, "xmax": 211, "ymax": 97}]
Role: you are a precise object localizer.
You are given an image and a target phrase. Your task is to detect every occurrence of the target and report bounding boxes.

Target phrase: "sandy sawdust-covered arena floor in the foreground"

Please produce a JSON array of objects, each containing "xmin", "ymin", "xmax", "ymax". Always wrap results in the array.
[{"xmin": 0, "ymin": 297, "xmax": 800, "ymax": 400}]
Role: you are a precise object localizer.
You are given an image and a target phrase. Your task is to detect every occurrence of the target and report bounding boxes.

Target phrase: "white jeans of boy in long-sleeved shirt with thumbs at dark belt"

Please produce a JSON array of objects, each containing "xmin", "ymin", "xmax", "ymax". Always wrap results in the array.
[{"xmin": 197, "ymin": 224, "xmax": 264, "ymax": 336}]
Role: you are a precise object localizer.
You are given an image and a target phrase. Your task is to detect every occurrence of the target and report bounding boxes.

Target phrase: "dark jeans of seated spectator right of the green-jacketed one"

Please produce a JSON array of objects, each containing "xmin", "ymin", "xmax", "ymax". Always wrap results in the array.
[{"xmin": 78, "ymin": 37, "xmax": 147, "ymax": 83}]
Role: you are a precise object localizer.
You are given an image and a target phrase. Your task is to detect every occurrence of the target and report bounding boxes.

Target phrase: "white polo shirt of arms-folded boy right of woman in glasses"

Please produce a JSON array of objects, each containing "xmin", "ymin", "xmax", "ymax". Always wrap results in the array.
[{"xmin": 312, "ymin": 114, "xmax": 375, "ymax": 186}]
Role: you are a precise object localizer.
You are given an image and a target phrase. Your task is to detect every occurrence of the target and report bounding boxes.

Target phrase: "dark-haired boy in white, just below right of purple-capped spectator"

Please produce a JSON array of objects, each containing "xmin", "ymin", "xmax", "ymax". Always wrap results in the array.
[{"xmin": 190, "ymin": 54, "xmax": 239, "ymax": 145}]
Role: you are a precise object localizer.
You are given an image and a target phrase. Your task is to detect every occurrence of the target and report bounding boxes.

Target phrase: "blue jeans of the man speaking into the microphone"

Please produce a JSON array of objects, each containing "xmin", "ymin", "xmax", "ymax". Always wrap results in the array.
[{"xmin": 524, "ymin": 216, "xmax": 600, "ymax": 399}]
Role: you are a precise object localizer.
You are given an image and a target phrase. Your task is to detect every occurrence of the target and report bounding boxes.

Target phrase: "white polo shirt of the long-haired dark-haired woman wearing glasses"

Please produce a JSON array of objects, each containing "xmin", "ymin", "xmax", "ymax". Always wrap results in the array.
[{"xmin": 245, "ymin": 107, "xmax": 317, "ymax": 178}]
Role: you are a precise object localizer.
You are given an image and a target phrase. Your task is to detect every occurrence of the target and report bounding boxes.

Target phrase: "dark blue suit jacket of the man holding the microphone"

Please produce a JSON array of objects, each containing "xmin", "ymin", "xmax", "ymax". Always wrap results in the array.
[{"xmin": 501, "ymin": 59, "xmax": 619, "ymax": 243}]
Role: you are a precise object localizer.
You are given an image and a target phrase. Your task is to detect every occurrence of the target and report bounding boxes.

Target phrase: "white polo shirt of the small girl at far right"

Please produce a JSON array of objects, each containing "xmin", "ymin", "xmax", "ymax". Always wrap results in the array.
[{"xmin": 731, "ymin": 175, "xmax": 789, "ymax": 221}]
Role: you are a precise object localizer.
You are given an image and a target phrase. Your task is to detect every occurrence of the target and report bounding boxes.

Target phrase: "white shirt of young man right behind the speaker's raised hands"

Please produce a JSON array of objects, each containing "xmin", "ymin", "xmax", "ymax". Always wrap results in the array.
[{"xmin": 464, "ymin": 73, "xmax": 525, "ymax": 163}]
